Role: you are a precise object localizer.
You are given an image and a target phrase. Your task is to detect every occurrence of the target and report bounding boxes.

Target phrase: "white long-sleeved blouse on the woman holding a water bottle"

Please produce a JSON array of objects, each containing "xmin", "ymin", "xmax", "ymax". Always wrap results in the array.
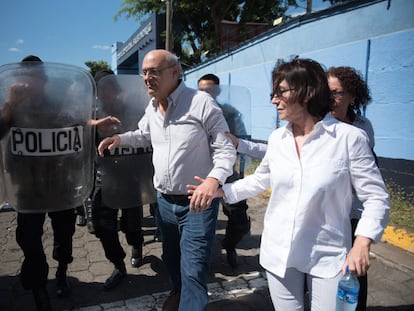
[{"xmin": 223, "ymin": 114, "xmax": 389, "ymax": 278}]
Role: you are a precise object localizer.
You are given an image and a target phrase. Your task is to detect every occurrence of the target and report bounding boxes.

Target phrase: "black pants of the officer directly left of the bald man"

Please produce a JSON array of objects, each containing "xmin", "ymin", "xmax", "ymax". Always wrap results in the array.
[{"xmin": 92, "ymin": 193, "xmax": 144, "ymax": 266}]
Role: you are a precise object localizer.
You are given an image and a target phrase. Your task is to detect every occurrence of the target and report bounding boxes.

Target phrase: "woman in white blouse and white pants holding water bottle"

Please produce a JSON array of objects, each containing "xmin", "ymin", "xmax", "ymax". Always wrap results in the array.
[{"xmin": 188, "ymin": 59, "xmax": 389, "ymax": 311}]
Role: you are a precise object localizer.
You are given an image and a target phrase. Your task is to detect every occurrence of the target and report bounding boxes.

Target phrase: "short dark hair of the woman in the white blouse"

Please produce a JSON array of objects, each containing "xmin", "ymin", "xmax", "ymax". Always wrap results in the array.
[{"xmin": 272, "ymin": 58, "xmax": 332, "ymax": 119}]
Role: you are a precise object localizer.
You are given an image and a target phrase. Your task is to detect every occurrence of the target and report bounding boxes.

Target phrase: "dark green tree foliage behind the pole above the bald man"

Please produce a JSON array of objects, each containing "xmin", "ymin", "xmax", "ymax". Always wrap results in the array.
[{"xmin": 115, "ymin": 0, "xmax": 288, "ymax": 65}]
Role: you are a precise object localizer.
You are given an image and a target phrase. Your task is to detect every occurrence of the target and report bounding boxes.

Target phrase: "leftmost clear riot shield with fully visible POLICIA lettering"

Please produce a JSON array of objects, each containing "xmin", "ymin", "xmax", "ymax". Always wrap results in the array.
[{"xmin": 0, "ymin": 62, "xmax": 95, "ymax": 213}]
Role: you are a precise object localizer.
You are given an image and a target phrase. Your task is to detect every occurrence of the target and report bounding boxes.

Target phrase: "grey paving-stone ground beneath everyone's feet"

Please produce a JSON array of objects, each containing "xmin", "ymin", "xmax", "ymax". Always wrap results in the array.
[{"xmin": 0, "ymin": 197, "xmax": 414, "ymax": 311}]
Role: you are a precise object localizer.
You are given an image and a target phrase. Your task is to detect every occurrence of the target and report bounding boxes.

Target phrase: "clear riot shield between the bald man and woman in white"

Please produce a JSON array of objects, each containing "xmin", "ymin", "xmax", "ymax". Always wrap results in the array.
[{"xmin": 214, "ymin": 85, "xmax": 251, "ymax": 182}]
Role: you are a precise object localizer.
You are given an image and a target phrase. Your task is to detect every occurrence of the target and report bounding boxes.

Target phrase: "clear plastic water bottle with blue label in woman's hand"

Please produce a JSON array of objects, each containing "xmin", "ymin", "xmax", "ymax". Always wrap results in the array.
[{"xmin": 335, "ymin": 266, "xmax": 359, "ymax": 311}]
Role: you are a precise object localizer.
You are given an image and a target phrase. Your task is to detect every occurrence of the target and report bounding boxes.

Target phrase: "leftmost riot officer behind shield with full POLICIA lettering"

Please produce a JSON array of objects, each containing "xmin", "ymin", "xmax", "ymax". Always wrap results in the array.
[{"xmin": 0, "ymin": 55, "xmax": 93, "ymax": 310}]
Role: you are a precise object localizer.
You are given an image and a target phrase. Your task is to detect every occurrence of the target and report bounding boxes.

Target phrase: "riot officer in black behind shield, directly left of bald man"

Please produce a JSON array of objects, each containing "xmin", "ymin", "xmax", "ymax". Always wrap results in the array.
[{"xmin": 92, "ymin": 70, "xmax": 155, "ymax": 290}]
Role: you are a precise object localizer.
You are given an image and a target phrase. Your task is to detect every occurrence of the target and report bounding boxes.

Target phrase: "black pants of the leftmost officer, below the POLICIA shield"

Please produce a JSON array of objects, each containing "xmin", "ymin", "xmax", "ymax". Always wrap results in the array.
[{"xmin": 16, "ymin": 209, "xmax": 76, "ymax": 289}]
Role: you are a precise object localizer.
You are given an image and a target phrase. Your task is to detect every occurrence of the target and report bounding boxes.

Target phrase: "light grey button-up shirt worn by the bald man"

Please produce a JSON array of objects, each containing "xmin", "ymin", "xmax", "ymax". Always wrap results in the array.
[{"xmin": 119, "ymin": 82, "xmax": 236, "ymax": 195}]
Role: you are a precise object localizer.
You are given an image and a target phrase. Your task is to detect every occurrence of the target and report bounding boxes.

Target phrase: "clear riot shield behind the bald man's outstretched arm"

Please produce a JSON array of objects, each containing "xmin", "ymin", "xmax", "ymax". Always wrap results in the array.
[{"xmin": 97, "ymin": 75, "xmax": 156, "ymax": 209}]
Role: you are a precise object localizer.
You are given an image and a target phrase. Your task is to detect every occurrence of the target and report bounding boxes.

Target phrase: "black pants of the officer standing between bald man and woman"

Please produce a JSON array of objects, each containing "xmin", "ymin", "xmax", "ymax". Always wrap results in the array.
[{"xmin": 221, "ymin": 200, "xmax": 250, "ymax": 248}]
